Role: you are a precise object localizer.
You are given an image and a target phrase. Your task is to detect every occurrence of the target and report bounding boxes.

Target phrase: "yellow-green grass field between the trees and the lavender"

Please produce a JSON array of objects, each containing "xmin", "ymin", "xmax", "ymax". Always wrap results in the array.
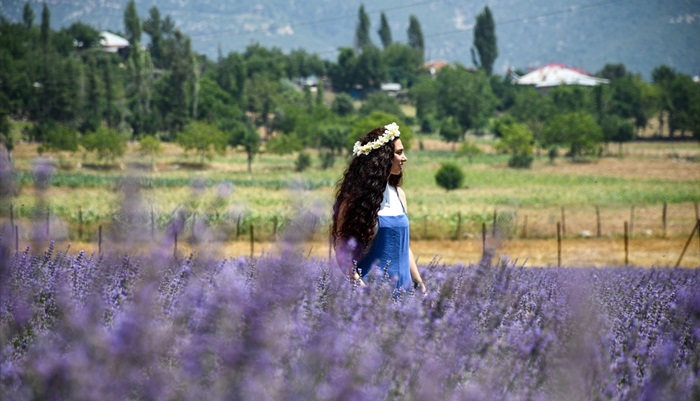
[{"xmin": 2, "ymin": 136, "xmax": 700, "ymax": 247}]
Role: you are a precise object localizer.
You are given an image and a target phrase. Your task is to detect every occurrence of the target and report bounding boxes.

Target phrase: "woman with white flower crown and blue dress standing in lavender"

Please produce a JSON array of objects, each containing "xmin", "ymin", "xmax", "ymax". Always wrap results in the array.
[{"xmin": 331, "ymin": 123, "xmax": 427, "ymax": 293}]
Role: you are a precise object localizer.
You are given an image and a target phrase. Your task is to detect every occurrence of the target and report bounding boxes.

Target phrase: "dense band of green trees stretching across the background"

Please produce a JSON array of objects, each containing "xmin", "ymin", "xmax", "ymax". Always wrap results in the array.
[{"xmin": 0, "ymin": 0, "xmax": 700, "ymax": 168}]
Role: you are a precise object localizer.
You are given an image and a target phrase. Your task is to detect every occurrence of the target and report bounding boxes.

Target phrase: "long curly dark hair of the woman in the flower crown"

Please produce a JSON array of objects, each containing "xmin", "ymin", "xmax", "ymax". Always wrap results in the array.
[{"xmin": 331, "ymin": 127, "xmax": 403, "ymax": 260}]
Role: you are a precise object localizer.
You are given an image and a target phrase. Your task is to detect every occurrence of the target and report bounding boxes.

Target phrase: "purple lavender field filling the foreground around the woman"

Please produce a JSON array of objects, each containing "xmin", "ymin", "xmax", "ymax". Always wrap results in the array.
[{"xmin": 0, "ymin": 231, "xmax": 700, "ymax": 400}]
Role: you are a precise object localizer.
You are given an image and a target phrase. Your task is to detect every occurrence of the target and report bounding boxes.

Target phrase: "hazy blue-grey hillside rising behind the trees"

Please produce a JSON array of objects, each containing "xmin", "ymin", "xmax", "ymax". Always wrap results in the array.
[{"xmin": 0, "ymin": 0, "xmax": 700, "ymax": 79}]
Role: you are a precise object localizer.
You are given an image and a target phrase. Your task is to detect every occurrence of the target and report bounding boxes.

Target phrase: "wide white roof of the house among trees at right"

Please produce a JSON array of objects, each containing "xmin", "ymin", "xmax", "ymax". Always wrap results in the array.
[{"xmin": 511, "ymin": 63, "xmax": 610, "ymax": 89}]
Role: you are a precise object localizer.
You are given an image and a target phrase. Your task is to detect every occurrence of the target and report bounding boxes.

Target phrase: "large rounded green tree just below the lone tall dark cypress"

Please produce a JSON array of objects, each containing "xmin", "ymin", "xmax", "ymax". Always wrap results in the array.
[{"xmin": 436, "ymin": 65, "xmax": 497, "ymax": 134}]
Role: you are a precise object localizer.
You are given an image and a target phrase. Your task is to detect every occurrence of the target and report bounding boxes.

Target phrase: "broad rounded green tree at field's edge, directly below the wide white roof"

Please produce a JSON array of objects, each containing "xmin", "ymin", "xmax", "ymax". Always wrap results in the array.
[{"xmin": 544, "ymin": 111, "xmax": 604, "ymax": 159}]
